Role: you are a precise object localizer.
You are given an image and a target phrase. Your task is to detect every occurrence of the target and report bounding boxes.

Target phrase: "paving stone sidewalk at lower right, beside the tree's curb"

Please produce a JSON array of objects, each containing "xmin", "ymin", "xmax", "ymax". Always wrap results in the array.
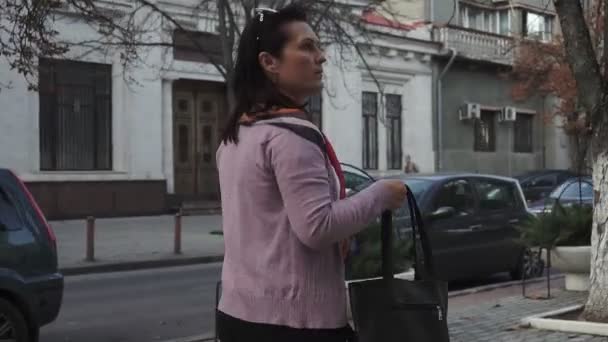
[{"xmin": 448, "ymin": 290, "xmax": 608, "ymax": 342}]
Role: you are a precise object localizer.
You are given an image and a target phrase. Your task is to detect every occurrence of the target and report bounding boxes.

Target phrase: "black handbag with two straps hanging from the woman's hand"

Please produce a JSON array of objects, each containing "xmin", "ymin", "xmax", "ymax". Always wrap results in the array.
[{"xmin": 349, "ymin": 188, "xmax": 450, "ymax": 342}]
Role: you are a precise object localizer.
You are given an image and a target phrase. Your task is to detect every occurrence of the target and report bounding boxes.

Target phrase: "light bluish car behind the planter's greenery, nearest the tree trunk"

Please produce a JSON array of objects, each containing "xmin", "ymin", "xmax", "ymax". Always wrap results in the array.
[{"xmin": 529, "ymin": 177, "xmax": 593, "ymax": 214}]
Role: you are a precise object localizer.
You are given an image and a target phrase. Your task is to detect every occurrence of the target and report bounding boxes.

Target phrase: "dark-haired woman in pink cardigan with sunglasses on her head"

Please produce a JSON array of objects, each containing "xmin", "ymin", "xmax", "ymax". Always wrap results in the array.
[{"xmin": 217, "ymin": 5, "xmax": 406, "ymax": 342}]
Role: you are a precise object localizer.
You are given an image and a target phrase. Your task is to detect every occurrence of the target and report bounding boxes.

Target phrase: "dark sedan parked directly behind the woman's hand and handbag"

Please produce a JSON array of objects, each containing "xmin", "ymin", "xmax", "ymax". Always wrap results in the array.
[{"xmin": 358, "ymin": 174, "xmax": 543, "ymax": 281}]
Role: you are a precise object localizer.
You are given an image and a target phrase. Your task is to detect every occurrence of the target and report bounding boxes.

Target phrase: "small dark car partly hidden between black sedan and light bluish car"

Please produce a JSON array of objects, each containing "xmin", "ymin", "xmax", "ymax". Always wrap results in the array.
[{"xmin": 515, "ymin": 170, "xmax": 577, "ymax": 203}]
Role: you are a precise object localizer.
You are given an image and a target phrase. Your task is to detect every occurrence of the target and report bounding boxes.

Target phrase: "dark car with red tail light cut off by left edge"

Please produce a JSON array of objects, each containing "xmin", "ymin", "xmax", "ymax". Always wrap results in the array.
[{"xmin": 0, "ymin": 169, "xmax": 63, "ymax": 342}]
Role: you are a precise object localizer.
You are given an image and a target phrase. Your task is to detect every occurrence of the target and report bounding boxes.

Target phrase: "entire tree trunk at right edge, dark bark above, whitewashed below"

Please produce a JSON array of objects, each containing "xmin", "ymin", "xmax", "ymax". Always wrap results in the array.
[{"xmin": 553, "ymin": 0, "xmax": 608, "ymax": 323}]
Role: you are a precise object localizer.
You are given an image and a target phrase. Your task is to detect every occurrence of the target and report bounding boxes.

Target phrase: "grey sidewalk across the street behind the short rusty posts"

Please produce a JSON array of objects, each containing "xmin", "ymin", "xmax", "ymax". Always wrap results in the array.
[{"xmin": 50, "ymin": 215, "xmax": 224, "ymax": 275}]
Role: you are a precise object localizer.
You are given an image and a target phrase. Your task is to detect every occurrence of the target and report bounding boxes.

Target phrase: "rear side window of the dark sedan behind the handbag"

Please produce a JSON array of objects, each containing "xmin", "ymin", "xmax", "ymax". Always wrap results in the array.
[{"xmin": 475, "ymin": 179, "xmax": 518, "ymax": 210}]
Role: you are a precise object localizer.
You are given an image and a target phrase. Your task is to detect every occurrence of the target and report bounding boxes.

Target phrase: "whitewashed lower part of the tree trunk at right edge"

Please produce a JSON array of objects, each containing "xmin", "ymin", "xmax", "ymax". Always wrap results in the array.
[{"xmin": 583, "ymin": 151, "xmax": 608, "ymax": 323}]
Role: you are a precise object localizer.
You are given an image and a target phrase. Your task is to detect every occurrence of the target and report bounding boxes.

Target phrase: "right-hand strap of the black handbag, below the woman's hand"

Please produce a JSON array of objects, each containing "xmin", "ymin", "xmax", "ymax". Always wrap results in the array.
[{"xmin": 405, "ymin": 185, "xmax": 435, "ymax": 280}]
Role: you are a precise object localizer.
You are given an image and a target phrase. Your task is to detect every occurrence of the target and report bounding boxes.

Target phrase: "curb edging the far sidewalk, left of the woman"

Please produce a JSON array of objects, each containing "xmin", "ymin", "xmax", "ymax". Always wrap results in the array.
[{"xmin": 59, "ymin": 255, "xmax": 224, "ymax": 276}]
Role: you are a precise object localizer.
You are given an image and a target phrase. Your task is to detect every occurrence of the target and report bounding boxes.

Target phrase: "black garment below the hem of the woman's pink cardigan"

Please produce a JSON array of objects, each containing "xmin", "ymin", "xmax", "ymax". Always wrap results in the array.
[{"xmin": 217, "ymin": 311, "xmax": 354, "ymax": 342}]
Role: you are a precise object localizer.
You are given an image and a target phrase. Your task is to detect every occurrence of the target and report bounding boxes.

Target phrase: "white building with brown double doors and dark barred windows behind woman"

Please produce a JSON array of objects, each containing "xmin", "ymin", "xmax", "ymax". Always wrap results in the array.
[{"xmin": 0, "ymin": 0, "xmax": 437, "ymax": 218}]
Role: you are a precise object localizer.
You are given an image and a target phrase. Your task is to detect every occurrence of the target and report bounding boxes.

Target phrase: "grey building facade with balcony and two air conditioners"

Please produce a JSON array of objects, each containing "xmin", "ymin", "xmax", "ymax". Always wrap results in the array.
[{"xmin": 403, "ymin": 0, "xmax": 570, "ymax": 176}]
